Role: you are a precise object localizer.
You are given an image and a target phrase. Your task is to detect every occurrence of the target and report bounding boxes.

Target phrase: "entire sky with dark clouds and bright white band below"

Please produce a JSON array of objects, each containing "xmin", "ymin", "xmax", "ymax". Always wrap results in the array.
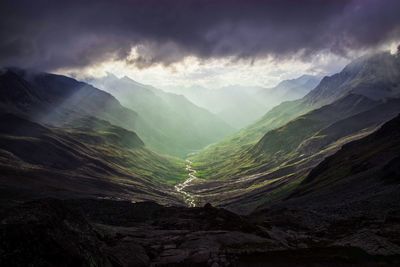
[{"xmin": 0, "ymin": 0, "xmax": 400, "ymax": 90}]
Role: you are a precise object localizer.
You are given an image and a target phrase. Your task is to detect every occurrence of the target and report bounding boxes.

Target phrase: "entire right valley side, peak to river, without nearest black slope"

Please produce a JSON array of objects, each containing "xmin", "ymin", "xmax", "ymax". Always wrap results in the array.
[{"xmin": 187, "ymin": 51, "xmax": 400, "ymax": 213}]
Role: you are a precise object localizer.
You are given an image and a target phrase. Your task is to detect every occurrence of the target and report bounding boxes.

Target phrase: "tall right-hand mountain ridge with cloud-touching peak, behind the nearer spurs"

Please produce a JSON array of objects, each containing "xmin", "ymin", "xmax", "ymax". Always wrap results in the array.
[{"xmin": 192, "ymin": 53, "xmax": 400, "ymax": 179}]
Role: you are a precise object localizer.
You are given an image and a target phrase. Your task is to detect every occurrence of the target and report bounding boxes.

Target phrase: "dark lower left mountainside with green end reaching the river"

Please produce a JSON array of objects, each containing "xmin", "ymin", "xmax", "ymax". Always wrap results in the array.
[{"xmin": 0, "ymin": 114, "xmax": 185, "ymax": 207}]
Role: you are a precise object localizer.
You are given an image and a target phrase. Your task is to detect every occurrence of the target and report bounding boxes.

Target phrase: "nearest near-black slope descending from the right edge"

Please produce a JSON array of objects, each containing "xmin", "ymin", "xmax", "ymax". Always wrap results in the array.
[{"xmin": 247, "ymin": 113, "xmax": 400, "ymax": 217}]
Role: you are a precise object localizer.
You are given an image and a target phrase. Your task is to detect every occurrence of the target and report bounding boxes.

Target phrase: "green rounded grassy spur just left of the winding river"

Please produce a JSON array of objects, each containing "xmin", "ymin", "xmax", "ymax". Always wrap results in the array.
[{"xmin": 65, "ymin": 117, "xmax": 186, "ymax": 184}]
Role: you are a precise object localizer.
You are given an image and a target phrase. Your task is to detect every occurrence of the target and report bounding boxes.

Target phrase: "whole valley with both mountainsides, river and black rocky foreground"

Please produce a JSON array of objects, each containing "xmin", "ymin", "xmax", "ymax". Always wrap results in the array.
[{"xmin": 0, "ymin": 50, "xmax": 400, "ymax": 266}]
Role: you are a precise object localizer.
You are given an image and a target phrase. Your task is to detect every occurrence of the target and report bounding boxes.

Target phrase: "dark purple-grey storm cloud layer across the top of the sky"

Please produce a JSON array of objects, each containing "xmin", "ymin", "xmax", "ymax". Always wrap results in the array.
[{"xmin": 0, "ymin": 0, "xmax": 400, "ymax": 69}]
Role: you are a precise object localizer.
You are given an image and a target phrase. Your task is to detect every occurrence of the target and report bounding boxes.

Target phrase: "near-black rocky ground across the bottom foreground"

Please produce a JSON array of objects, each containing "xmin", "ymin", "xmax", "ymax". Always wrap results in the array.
[{"xmin": 0, "ymin": 199, "xmax": 400, "ymax": 267}]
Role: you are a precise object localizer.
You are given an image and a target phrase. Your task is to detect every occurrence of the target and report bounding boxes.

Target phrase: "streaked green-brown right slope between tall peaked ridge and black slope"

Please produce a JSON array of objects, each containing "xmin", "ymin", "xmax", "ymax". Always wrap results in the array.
[{"xmin": 188, "ymin": 95, "xmax": 400, "ymax": 213}]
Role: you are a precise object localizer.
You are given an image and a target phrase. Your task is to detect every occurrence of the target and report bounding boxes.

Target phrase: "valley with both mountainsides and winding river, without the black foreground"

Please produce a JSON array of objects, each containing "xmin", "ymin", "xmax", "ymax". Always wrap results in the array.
[{"xmin": 0, "ymin": 52, "xmax": 400, "ymax": 211}]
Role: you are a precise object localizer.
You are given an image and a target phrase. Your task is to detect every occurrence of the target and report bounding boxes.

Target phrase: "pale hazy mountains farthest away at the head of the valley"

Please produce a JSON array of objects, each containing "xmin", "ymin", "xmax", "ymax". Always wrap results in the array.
[{"xmin": 170, "ymin": 75, "xmax": 320, "ymax": 129}]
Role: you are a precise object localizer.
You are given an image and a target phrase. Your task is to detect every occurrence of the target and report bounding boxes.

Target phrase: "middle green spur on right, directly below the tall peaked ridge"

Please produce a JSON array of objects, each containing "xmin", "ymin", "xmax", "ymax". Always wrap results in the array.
[{"xmin": 195, "ymin": 95, "xmax": 375, "ymax": 179}]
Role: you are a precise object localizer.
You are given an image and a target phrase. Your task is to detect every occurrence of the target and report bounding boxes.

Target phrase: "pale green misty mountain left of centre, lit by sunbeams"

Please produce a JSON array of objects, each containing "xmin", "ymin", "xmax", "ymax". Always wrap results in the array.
[{"xmin": 91, "ymin": 74, "xmax": 233, "ymax": 157}]
